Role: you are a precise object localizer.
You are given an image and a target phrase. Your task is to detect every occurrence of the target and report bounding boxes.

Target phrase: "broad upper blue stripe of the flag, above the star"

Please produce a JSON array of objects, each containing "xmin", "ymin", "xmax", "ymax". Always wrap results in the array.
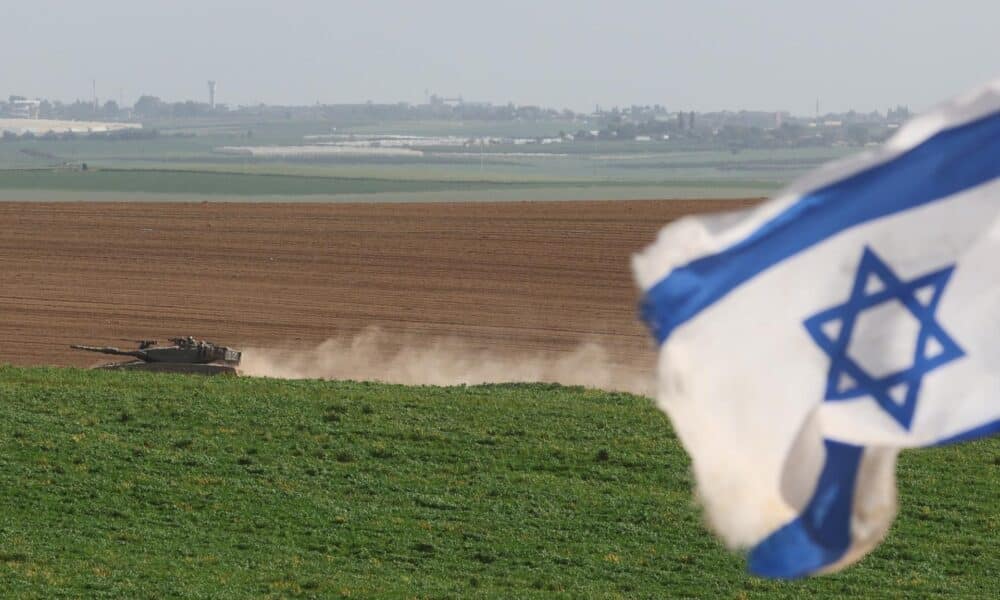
[{"xmin": 640, "ymin": 107, "xmax": 1000, "ymax": 344}]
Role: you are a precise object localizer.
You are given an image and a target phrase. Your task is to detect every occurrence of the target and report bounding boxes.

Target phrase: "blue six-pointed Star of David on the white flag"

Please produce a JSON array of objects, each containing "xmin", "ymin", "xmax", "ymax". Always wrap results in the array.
[{"xmin": 805, "ymin": 247, "xmax": 965, "ymax": 430}]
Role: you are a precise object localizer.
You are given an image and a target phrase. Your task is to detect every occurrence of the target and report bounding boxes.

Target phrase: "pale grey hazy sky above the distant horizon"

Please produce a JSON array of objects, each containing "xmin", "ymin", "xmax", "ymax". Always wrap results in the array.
[{"xmin": 0, "ymin": 0, "xmax": 1000, "ymax": 114}]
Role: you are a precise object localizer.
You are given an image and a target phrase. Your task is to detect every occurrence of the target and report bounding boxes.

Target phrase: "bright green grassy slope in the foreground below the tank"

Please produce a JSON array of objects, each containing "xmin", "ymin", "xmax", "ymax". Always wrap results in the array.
[{"xmin": 0, "ymin": 367, "xmax": 1000, "ymax": 598}]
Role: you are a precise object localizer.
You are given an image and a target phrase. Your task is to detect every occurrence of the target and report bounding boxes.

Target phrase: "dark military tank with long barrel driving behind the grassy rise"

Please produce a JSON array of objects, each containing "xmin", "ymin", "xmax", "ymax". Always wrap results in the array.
[{"xmin": 70, "ymin": 336, "xmax": 243, "ymax": 375}]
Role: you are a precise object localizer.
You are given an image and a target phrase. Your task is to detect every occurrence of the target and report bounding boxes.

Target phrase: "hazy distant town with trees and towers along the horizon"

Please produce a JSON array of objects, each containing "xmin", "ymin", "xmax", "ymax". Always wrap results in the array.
[{"xmin": 0, "ymin": 82, "xmax": 910, "ymax": 151}]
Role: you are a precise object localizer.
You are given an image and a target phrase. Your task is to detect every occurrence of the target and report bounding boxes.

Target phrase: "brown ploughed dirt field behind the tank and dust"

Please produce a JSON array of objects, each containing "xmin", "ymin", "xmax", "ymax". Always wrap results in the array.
[{"xmin": 0, "ymin": 200, "xmax": 748, "ymax": 390}]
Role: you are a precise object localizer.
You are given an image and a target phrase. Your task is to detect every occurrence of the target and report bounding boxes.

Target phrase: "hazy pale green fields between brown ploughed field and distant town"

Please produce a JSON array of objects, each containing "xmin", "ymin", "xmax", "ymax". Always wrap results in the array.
[{"xmin": 0, "ymin": 120, "xmax": 857, "ymax": 201}]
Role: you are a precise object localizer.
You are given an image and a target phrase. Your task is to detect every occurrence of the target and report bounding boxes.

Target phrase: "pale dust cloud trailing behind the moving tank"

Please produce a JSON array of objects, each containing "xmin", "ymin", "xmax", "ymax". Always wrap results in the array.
[{"xmin": 240, "ymin": 327, "xmax": 653, "ymax": 396}]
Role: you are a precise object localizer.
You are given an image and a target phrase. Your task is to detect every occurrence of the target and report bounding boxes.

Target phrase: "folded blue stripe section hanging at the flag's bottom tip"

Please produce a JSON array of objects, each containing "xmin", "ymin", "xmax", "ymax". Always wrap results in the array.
[{"xmin": 749, "ymin": 440, "xmax": 864, "ymax": 579}]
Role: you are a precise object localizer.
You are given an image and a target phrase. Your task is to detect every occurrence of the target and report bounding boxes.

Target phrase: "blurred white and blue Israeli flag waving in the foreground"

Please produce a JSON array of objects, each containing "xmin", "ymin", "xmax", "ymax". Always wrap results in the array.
[{"xmin": 633, "ymin": 80, "xmax": 1000, "ymax": 578}]
